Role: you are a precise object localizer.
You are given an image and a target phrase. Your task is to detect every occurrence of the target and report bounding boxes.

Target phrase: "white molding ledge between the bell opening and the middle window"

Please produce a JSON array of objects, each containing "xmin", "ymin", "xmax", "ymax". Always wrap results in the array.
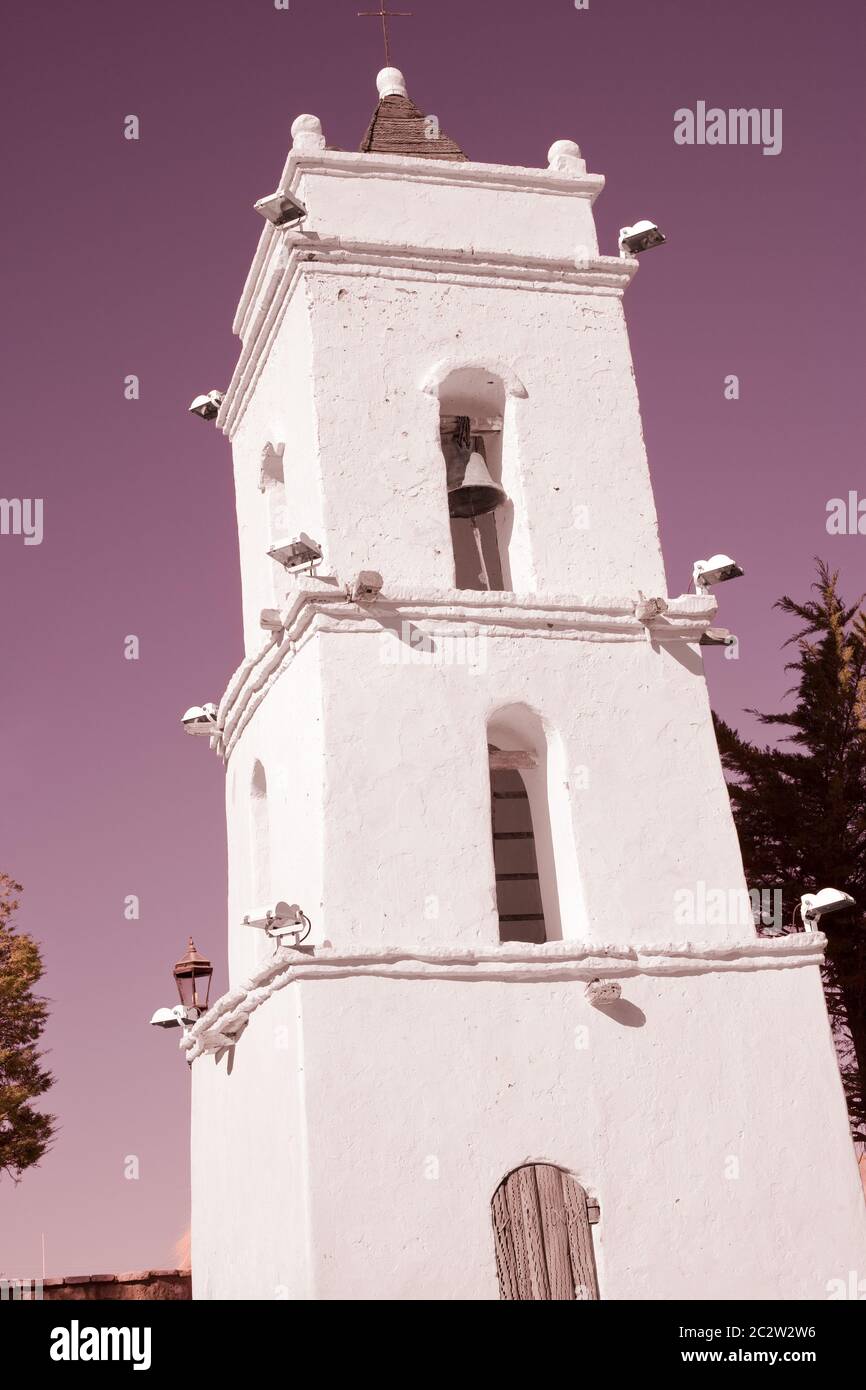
[{"xmin": 211, "ymin": 580, "xmax": 717, "ymax": 762}]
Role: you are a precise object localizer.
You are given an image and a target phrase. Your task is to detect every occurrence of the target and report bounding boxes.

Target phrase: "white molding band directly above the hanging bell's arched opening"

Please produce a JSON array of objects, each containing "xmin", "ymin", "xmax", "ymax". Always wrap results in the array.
[{"xmin": 217, "ymin": 239, "xmax": 638, "ymax": 436}]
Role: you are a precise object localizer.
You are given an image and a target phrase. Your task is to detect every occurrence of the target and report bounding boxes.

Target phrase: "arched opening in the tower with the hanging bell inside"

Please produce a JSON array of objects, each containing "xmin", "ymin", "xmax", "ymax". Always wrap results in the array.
[{"xmin": 439, "ymin": 367, "xmax": 514, "ymax": 591}]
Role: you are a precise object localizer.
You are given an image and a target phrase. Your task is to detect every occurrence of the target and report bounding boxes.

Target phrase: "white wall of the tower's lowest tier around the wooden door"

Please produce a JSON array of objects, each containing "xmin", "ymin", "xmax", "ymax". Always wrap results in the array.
[{"xmin": 193, "ymin": 950, "xmax": 866, "ymax": 1300}]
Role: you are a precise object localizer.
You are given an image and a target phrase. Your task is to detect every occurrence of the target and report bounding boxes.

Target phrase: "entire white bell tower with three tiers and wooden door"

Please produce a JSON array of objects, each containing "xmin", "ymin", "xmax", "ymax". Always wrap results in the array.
[{"xmin": 183, "ymin": 68, "xmax": 866, "ymax": 1300}]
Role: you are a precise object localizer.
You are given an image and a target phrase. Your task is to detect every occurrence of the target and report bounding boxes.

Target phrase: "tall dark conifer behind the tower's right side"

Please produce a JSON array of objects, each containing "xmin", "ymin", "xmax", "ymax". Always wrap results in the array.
[{"xmin": 716, "ymin": 560, "xmax": 866, "ymax": 1140}]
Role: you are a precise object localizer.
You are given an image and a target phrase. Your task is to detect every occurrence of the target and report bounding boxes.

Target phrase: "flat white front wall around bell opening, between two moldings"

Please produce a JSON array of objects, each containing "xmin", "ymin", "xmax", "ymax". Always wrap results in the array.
[{"xmin": 310, "ymin": 274, "xmax": 666, "ymax": 595}]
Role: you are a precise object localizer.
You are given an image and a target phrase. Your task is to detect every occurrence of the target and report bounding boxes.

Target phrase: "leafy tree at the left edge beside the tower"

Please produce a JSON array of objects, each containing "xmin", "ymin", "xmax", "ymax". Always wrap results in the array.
[{"xmin": 0, "ymin": 873, "xmax": 54, "ymax": 1182}]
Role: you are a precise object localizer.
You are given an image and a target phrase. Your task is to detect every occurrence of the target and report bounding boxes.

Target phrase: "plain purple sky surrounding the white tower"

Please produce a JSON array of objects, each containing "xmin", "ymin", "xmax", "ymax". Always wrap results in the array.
[{"xmin": 0, "ymin": 0, "xmax": 866, "ymax": 1276}]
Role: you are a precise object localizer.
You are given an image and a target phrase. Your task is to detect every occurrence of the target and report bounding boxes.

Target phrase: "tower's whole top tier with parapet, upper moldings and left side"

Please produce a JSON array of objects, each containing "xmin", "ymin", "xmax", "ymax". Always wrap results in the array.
[{"xmin": 221, "ymin": 139, "xmax": 666, "ymax": 653}]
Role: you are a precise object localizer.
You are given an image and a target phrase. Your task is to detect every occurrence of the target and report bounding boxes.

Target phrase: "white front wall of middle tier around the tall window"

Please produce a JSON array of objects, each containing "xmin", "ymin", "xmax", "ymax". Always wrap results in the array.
[{"xmin": 315, "ymin": 617, "xmax": 745, "ymax": 947}]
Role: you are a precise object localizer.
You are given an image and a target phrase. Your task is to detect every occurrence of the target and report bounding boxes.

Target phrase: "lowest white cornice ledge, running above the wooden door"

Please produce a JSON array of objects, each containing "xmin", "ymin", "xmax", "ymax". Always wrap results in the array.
[{"xmin": 181, "ymin": 931, "xmax": 827, "ymax": 1062}]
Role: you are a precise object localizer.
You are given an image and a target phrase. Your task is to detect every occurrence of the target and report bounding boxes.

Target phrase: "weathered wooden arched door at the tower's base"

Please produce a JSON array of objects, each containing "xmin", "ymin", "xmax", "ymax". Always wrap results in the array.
[{"xmin": 492, "ymin": 1163, "xmax": 599, "ymax": 1302}]
